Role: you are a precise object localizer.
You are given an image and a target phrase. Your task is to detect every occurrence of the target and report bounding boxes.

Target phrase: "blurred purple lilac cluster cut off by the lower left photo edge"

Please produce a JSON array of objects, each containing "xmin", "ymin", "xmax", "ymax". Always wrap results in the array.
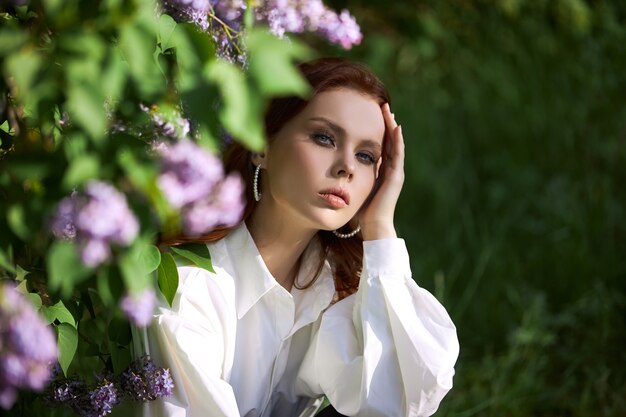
[{"xmin": 0, "ymin": 283, "xmax": 58, "ymax": 409}]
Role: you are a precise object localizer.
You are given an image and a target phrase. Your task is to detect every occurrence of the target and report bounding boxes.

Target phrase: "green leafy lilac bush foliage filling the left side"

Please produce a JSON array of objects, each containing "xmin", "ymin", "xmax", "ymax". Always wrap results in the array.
[{"xmin": 0, "ymin": 0, "xmax": 322, "ymax": 415}]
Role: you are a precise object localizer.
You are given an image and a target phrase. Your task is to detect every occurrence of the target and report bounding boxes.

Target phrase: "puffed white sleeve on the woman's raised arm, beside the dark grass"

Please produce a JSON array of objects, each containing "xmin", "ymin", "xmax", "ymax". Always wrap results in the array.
[{"xmin": 297, "ymin": 239, "xmax": 459, "ymax": 417}]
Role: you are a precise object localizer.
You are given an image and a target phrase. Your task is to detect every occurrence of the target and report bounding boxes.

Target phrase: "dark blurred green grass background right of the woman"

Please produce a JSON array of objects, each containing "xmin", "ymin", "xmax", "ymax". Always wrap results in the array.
[{"xmin": 320, "ymin": 0, "xmax": 626, "ymax": 417}]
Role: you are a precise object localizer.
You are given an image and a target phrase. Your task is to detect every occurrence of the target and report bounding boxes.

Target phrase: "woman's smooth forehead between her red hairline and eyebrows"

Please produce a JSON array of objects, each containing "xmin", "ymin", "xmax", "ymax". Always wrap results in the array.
[{"xmin": 300, "ymin": 89, "xmax": 385, "ymax": 143}]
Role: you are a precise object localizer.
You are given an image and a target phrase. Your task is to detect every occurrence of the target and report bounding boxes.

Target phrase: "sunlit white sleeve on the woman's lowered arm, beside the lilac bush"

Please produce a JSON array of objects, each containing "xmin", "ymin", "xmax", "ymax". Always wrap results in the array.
[{"xmin": 142, "ymin": 267, "xmax": 240, "ymax": 417}]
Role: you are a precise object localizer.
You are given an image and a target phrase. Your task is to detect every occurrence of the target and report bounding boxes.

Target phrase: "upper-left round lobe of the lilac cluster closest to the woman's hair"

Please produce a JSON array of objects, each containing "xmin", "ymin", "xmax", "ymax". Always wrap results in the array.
[{"xmin": 158, "ymin": 140, "xmax": 224, "ymax": 209}]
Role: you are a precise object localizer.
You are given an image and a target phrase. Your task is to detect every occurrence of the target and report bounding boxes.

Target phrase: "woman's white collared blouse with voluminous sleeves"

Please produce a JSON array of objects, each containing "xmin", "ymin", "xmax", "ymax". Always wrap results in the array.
[{"xmin": 138, "ymin": 224, "xmax": 459, "ymax": 417}]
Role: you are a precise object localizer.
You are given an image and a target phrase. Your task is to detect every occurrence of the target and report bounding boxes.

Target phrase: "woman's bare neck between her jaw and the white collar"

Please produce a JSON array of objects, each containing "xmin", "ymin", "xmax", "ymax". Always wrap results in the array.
[{"xmin": 246, "ymin": 204, "xmax": 317, "ymax": 291}]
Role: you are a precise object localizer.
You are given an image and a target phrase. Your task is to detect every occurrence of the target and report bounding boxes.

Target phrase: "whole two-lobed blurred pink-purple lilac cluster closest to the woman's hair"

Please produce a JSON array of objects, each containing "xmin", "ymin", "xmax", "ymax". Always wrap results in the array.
[{"xmin": 157, "ymin": 140, "xmax": 245, "ymax": 236}]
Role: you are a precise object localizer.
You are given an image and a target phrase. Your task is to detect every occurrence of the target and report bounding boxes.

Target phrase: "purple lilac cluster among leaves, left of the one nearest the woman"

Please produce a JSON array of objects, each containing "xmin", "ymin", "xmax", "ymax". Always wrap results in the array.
[{"xmin": 51, "ymin": 181, "xmax": 139, "ymax": 267}]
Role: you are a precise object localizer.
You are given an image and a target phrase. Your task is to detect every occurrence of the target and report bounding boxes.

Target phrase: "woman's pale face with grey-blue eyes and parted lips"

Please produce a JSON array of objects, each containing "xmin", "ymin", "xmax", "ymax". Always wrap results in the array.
[{"xmin": 254, "ymin": 89, "xmax": 385, "ymax": 230}]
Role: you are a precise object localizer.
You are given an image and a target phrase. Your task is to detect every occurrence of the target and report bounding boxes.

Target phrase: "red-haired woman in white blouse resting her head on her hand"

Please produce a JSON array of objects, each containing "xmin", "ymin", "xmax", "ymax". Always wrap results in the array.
[{"xmin": 138, "ymin": 59, "xmax": 458, "ymax": 417}]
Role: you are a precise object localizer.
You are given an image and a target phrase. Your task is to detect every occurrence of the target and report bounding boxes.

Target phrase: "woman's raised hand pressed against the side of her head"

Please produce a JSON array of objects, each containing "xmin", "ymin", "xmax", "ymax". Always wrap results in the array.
[{"xmin": 359, "ymin": 103, "xmax": 404, "ymax": 240}]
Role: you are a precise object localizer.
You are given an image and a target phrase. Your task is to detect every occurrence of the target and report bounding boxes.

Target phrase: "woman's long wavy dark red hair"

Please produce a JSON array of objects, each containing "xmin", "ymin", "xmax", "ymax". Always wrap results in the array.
[{"xmin": 163, "ymin": 58, "xmax": 390, "ymax": 299}]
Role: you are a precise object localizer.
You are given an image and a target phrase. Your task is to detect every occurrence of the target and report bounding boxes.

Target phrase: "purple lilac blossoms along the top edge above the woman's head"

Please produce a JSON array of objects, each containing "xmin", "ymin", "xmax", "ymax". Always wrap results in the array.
[{"xmin": 162, "ymin": 0, "xmax": 363, "ymax": 64}]
